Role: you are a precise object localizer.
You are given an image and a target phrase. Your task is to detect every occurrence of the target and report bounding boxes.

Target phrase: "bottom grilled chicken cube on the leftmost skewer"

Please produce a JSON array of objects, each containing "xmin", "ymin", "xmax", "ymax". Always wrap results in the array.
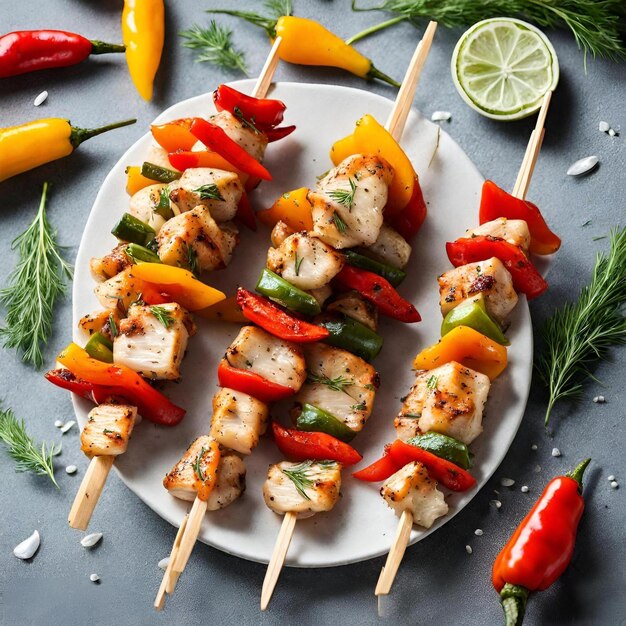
[{"xmin": 80, "ymin": 402, "xmax": 137, "ymax": 456}]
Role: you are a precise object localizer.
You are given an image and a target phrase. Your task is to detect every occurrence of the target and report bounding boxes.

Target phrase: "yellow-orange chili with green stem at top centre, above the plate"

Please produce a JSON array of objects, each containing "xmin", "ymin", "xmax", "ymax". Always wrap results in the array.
[{"xmin": 274, "ymin": 15, "xmax": 400, "ymax": 87}]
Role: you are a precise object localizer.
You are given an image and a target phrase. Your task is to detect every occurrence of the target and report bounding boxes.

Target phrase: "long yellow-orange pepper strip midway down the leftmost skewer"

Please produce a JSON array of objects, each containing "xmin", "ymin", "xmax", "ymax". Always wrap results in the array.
[{"xmin": 133, "ymin": 263, "xmax": 226, "ymax": 311}]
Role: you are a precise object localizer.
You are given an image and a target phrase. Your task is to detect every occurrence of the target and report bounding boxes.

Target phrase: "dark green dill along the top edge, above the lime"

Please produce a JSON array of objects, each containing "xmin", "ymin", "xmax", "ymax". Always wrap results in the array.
[{"xmin": 348, "ymin": 0, "xmax": 626, "ymax": 61}]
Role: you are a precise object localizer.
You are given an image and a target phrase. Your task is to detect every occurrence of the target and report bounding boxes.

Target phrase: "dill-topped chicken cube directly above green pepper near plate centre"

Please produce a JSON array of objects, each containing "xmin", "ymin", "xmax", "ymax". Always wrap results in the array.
[{"xmin": 267, "ymin": 230, "xmax": 345, "ymax": 289}]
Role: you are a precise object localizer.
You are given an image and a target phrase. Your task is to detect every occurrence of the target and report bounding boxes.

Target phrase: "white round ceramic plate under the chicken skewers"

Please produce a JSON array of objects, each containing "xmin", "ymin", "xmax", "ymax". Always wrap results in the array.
[{"xmin": 73, "ymin": 81, "xmax": 532, "ymax": 567}]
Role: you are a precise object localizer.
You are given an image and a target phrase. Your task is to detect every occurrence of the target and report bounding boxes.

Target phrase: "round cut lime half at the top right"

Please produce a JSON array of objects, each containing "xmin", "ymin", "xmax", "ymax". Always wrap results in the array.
[{"xmin": 452, "ymin": 18, "xmax": 559, "ymax": 120}]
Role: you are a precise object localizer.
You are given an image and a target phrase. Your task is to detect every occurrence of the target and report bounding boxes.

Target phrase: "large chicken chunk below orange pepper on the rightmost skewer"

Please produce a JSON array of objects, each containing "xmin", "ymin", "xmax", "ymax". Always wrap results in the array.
[{"xmin": 395, "ymin": 361, "xmax": 491, "ymax": 445}]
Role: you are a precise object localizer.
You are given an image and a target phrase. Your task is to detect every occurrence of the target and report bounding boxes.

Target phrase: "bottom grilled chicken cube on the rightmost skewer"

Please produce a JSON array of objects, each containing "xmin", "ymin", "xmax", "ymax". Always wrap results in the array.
[{"xmin": 380, "ymin": 461, "xmax": 448, "ymax": 528}]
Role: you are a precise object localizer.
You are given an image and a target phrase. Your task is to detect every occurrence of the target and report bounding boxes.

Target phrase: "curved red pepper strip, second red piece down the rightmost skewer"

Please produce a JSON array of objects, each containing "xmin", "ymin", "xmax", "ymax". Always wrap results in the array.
[{"xmin": 446, "ymin": 235, "xmax": 548, "ymax": 300}]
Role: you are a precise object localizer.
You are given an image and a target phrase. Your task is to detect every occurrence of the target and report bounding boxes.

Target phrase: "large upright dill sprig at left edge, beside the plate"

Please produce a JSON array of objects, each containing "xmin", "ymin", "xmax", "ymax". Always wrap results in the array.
[{"xmin": 0, "ymin": 183, "xmax": 72, "ymax": 368}]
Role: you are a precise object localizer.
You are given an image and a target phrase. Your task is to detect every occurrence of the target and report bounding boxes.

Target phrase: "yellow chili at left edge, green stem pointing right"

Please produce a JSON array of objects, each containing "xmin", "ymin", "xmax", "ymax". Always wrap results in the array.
[{"xmin": 0, "ymin": 117, "xmax": 137, "ymax": 182}]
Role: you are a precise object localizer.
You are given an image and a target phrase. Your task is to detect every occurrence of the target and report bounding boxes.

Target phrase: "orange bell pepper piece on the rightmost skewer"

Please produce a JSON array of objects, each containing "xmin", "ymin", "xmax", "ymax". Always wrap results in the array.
[{"xmin": 413, "ymin": 326, "xmax": 507, "ymax": 380}]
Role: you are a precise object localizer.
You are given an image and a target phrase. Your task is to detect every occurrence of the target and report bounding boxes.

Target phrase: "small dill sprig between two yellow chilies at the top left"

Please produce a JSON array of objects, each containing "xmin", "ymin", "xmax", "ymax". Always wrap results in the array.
[{"xmin": 179, "ymin": 20, "xmax": 248, "ymax": 76}]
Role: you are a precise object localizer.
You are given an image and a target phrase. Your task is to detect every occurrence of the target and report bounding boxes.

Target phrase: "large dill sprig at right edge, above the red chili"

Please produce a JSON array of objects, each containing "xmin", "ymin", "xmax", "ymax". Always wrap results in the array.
[{"xmin": 536, "ymin": 228, "xmax": 626, "ymax": 425}]
